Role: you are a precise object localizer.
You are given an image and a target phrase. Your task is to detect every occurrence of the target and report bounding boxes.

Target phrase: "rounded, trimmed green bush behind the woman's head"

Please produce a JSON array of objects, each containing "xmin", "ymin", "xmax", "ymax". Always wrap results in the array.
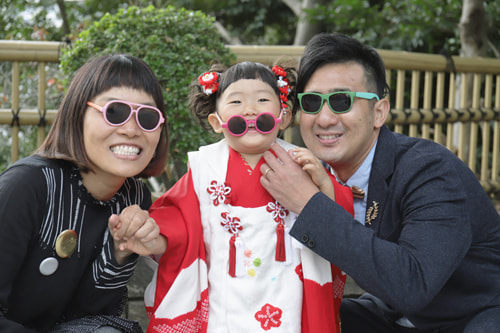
[{"xmin": 61, "ymin": 6, "xmax": 235, "ymax": 182}]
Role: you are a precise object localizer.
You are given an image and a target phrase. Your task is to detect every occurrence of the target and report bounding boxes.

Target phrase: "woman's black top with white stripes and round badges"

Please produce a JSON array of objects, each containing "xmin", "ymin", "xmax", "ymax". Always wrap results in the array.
[{"xmin": 0, "ymin": 155, "xmax": 151, "ymax": 332}]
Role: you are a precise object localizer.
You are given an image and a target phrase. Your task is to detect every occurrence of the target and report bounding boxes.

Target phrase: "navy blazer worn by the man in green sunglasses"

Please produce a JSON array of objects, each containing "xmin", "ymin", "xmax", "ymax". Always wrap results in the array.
[{"xmin": 290, "ymin": 126, "xmax": 500, "ymax": 329}]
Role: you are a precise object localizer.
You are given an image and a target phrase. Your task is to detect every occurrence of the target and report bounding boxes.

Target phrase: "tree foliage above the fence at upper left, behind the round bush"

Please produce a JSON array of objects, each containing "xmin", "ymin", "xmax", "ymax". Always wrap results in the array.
[{"xmin": 0, "ymin": 0, "xmax": 296, "ymax": 45}]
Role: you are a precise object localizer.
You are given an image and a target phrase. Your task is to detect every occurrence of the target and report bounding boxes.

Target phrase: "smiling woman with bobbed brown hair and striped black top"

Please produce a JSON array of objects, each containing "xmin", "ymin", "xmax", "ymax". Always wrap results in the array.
[{"xmin": 0, "ymin": 55, "xmax": 168, "ymax": 332}]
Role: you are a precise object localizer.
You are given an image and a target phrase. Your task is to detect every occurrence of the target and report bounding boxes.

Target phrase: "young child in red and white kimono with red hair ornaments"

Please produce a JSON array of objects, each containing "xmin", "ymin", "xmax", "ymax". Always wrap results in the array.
[{"xmin": 145, "ymin": 62, "xmax": 352, "ymax": 333}]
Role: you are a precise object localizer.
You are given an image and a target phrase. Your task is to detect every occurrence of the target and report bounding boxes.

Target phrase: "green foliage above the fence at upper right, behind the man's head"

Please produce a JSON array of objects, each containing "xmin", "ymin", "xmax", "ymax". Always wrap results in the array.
[{"xmin": 308, "ymin": 0, "xmax": 500, "ymax": 56}]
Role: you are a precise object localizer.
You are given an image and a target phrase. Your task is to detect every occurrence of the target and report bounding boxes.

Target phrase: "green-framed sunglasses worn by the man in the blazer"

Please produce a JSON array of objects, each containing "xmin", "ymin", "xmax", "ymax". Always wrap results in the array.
[{"xmin": 297, "ymin": 91, "xmax": 380, "ymax": 113}]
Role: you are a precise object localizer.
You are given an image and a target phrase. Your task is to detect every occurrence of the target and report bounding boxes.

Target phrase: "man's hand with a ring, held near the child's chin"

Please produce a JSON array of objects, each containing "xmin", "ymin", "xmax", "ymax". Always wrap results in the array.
[{"xmin": 260, "ymin": 143, "xmax": 319, "ymax": 214}]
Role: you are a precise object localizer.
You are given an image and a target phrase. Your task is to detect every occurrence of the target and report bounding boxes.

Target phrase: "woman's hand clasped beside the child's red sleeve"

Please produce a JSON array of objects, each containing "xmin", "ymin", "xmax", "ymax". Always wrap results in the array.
[{"xmin": 108, "ymin": 205, "xmax": 167, "ymax": 263}]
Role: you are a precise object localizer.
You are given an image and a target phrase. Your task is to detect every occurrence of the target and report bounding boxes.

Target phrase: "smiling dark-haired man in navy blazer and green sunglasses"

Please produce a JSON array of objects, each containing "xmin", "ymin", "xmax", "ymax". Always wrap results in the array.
[{"xmin": 261, "ymin": 34, "xmax": 500, "ymax": 333}]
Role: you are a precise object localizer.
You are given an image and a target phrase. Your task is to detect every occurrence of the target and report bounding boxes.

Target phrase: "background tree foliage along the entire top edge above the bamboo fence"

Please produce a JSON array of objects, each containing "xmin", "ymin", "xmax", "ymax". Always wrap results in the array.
[{"xmin": 0, "ymin": 0, "xmax": 500, "ymax": 52}]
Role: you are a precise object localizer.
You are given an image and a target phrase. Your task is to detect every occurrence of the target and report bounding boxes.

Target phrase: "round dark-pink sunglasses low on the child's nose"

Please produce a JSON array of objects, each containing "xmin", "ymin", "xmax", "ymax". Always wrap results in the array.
[{"xmin": 215, "ymin": 110, "xmax": 283, "ymax": 136}]
